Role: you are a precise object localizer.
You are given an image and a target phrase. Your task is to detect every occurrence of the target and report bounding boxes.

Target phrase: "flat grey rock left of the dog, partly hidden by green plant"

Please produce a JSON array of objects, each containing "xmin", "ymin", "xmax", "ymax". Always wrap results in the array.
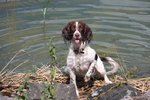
[{"xmin": 28, "ymin": 83, "xmax": 77, "ymax": 100}]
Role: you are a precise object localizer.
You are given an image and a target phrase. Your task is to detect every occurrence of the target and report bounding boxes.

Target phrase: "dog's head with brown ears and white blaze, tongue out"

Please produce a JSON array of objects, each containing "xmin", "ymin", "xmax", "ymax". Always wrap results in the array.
[{"xmin": 62, "ymin": 21, "xmax": 93, "ymax": 44}]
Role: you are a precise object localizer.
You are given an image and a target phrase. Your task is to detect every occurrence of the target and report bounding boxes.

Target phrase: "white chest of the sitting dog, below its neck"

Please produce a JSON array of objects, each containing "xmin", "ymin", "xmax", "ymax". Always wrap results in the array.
[{"xmin": 67, "ymin": 48, "xmax": 95, "ymax": 75}]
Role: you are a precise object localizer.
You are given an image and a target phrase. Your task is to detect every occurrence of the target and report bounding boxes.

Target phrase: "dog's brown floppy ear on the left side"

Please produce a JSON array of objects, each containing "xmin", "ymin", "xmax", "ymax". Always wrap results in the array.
[{"xmin": 62, "ymin": 22, "xmax": 72, "ymax": 41}]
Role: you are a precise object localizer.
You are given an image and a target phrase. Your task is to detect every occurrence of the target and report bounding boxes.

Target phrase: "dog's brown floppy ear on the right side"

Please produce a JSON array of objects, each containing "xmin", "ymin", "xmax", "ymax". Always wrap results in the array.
[{"xmin": 84, "ymin": 24, "xmax": 93, "ymax": 42}]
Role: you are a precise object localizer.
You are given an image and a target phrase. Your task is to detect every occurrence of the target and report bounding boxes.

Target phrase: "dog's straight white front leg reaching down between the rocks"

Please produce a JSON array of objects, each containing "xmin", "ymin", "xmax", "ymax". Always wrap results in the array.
[{"xmin": 68, "ymin": 68, "xmax": 79, "ymax": 98}]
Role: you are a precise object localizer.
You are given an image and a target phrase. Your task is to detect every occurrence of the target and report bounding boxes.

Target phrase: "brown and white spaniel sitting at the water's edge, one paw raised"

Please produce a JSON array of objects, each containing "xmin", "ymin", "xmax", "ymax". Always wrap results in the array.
[{"xmin": 62, "ymin": 21, "xmax": 119, "ymax": 97}]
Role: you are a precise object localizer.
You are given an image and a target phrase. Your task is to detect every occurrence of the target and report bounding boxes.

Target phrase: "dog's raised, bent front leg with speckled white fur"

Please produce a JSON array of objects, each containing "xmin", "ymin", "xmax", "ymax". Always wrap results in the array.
[{"xmin": 84, "ymin": 60, "xmax": 96, "ymax": 82}]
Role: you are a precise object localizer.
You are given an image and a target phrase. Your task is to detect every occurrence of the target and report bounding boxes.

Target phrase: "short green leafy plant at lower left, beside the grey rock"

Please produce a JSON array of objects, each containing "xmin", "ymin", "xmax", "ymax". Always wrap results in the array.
[{"xmin": 17, "ymin": 78, "xmax": 29, "ymax": 100}]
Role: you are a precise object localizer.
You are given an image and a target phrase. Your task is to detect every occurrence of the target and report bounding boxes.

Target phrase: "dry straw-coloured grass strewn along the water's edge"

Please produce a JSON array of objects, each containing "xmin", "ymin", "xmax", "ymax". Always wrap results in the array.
[{"xmin": 0, "ymin": 65, "xmax": 150, "ymax": 97}]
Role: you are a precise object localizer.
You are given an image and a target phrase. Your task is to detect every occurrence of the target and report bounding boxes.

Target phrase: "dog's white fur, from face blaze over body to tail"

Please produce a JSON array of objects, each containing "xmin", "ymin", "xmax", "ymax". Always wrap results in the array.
[{"xmin": 61, "ymin": 22, "xmax": 119, "ymax": 97}]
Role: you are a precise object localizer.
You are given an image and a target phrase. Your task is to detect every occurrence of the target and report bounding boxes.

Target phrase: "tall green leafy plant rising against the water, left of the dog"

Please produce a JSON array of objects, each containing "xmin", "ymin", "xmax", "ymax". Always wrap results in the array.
[{"xmin": 41, "ymin": 37, "xmax": 57, "ymax": 100}]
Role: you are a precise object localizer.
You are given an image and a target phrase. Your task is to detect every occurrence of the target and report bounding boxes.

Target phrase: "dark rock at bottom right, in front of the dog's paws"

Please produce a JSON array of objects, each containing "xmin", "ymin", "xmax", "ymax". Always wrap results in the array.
[{"xmin": 88, "ymin": 84, "xmax": 140, "ymax": 100}]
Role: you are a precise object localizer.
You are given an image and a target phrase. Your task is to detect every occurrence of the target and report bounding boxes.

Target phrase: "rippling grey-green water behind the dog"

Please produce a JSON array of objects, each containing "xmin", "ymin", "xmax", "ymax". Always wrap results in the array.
[{"xmin": 0, "ymin": 0, "xmax": 150, "ymax": 76}]
